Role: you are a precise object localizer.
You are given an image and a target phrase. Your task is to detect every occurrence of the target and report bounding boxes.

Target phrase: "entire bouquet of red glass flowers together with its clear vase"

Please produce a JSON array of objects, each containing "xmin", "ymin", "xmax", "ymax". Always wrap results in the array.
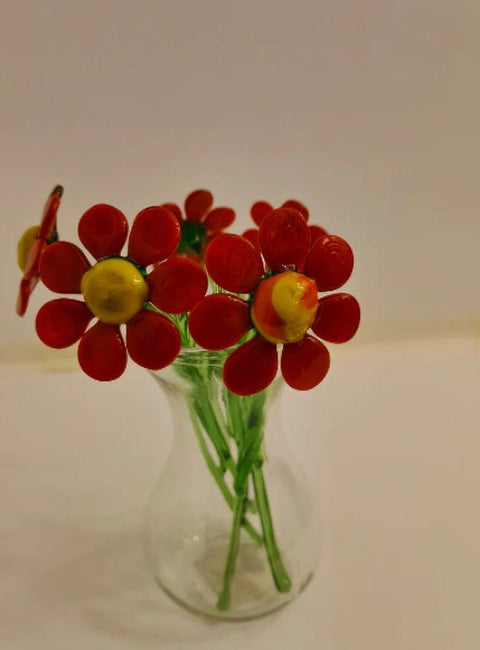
[{"xmin": 17, "ymin": 186, "xmax": 360, "ymax": 618}]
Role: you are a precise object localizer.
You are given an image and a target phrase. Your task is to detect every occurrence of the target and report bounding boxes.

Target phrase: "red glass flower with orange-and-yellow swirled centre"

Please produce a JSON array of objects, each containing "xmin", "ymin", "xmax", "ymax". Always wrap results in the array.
[{"xmin": 189, "ymin": 206, "xmax": 360, "ymax": 395}]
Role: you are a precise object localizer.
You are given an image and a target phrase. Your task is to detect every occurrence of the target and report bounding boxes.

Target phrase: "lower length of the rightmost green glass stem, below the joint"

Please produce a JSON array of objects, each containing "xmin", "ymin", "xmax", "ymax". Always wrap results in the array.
[{"xmin": 252, "ymin": 462, "xmax": 292, "ymax": 593}]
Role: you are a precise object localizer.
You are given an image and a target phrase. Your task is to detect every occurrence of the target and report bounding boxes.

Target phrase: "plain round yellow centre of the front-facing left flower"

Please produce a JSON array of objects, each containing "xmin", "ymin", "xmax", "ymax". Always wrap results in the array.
[{"xmin": 82, "ymin": 257, "xmax": 148, "ymax": 325}]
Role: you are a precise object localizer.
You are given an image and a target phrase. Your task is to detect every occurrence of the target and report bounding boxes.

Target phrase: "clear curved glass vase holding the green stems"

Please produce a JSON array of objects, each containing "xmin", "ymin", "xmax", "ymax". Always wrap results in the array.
[{"xmin": 147, "ymin": 349, "xmax": 319, "ymax": 620}]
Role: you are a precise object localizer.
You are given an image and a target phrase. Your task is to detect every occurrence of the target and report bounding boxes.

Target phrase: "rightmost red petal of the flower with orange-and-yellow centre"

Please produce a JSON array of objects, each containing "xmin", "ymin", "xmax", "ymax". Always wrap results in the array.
[{"xmin": 312, "ymin": 293, "xmax": 360, "ymax": 343}]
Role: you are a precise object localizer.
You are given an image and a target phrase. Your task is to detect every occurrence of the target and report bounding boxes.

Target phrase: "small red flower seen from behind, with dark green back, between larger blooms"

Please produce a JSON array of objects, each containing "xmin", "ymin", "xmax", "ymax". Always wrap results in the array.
[{"xmin": 162, "ymin": 190, "xmax": 235, "ymax": 259}]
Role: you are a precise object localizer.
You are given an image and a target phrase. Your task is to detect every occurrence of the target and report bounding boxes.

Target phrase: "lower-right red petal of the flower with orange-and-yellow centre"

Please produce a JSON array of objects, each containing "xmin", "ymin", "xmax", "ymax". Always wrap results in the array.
[{"xmin": 282, "ymin": 334, "xmax": 330, "ymax": 390}]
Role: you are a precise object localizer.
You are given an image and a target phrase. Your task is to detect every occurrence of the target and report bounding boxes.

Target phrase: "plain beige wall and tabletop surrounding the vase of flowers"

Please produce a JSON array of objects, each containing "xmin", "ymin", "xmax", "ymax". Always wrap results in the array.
[{"xmin": 0, "ymin": 0, "xmax": 480, "ymax": 650}]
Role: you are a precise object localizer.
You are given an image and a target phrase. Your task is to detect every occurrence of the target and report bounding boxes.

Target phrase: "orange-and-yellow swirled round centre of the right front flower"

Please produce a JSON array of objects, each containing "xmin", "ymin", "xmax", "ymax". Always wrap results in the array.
[{"xmin": 251, "ymin": 271, "xmax": 318, "ymax": 343}]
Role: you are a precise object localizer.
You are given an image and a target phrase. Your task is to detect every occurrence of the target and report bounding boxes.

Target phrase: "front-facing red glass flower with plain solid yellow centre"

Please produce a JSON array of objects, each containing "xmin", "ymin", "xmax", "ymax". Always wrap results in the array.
[{"xmin": 36, "ymin": 204, "xmax": 208, "ymax": 381}]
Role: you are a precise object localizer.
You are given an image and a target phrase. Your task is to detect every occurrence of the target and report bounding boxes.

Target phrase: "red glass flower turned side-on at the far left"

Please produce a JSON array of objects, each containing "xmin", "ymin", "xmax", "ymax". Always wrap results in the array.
[{"xmin": 17, "ymin": 185, "xmax": 63, "ymax": 316}]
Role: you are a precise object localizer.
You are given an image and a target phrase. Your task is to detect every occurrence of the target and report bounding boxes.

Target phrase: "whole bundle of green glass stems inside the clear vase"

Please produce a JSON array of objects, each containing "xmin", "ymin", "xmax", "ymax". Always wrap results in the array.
[{"xmin": 173, "ymin": 350, "xmax": 291, "ymax": 611}]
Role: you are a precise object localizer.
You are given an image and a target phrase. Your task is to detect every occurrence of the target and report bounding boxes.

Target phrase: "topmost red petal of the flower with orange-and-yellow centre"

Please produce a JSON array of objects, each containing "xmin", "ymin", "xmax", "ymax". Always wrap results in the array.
[{"xmin": 260, "ymin": 208, "xmax": 310, "ymax": 271}]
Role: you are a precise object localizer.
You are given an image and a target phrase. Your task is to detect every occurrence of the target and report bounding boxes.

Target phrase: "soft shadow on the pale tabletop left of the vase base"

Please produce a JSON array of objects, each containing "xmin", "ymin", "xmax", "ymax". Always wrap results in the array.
[{"xmin": 31, "ymin": 529, "xmax": 276, "ymax": 648}]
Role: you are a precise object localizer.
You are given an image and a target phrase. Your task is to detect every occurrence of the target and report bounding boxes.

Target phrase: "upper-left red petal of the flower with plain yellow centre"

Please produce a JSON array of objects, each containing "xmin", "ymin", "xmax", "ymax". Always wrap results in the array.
[{"xmin": 40, "ymin": 241, "xmax": 90, "ymax": 293}]
